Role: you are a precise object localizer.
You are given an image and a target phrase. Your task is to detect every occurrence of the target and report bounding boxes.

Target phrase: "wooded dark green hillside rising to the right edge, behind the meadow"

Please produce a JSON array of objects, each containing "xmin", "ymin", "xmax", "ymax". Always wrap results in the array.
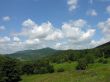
[{"xmin": 45, "ymin": 42, "xmax": 110, "ymax": 63}]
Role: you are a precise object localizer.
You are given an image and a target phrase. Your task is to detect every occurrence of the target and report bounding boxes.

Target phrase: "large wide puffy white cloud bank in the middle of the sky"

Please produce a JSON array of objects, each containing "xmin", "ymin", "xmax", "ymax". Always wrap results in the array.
[{"xmin": 20, "ymin": 19, "xmax": 94, "ymax": 41}]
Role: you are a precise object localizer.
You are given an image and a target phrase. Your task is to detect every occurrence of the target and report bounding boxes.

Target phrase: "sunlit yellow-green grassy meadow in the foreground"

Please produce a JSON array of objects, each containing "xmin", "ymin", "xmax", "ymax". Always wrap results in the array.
[{"xmin": 21, "ymin": 62, "xmax": 110, "ymax": 82}]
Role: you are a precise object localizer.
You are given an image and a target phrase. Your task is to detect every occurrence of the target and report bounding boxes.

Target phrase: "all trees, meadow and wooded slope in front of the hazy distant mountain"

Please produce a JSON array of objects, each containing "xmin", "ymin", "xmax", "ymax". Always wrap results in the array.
[{"xmin": 0, "ymin": 41, "xmax": 110, "ymax": 82}]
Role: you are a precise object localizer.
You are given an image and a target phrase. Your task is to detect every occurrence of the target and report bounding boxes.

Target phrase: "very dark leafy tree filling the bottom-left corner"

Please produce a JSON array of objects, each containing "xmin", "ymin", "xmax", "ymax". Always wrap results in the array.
[{"xmin": 0, "ymin": 59, "xmax": 21, "ymax": 82}]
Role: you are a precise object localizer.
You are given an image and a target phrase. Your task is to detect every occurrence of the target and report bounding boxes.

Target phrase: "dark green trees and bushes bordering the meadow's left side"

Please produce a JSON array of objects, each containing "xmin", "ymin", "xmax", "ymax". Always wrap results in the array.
[{"xmin": 0, "ymin": 56, "xmax": 54, "ymax": 82}]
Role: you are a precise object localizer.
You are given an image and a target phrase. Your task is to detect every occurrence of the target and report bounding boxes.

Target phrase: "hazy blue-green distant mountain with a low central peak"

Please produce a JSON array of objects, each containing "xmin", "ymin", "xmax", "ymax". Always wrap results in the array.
[{"xmin": 8, "ymin": 48, "xmax": 59, "ymax": 60}]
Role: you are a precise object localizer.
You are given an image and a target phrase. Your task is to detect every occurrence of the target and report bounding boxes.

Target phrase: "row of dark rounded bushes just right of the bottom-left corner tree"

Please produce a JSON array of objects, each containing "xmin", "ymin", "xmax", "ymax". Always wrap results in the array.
[{"xmin": 22, "ymin": 61, "xmax": 54, "ymax": 75}]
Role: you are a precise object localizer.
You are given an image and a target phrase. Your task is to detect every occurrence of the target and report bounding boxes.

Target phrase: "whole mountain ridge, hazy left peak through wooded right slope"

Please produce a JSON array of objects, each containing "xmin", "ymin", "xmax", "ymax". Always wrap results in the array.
[{"xmin": 8, "ymin": 42, "xmax": 110, "ymax": 62}]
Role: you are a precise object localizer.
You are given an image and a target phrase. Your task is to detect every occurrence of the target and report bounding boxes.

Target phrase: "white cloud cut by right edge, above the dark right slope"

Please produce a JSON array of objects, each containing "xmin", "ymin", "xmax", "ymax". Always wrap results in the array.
[{"xmin": 90, "ymin": 18, "xmax": 110, "ymax": 47}]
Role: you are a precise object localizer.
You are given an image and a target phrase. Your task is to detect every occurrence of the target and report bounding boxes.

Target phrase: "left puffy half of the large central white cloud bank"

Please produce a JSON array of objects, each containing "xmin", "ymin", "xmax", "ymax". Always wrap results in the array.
[{"xmin": 20, "ymin": 19, "xmax": 53, "ymax": 38}]
